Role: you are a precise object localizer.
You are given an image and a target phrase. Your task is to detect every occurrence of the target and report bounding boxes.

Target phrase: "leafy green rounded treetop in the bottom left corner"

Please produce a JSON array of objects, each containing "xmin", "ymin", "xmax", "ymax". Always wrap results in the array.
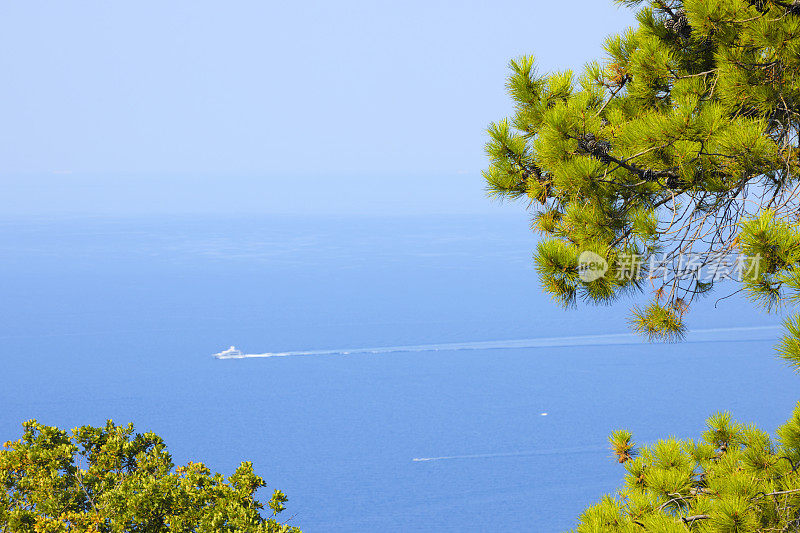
[{"xmin": 0, "ymin": 420, "xmax": 300, "ymax": 533}]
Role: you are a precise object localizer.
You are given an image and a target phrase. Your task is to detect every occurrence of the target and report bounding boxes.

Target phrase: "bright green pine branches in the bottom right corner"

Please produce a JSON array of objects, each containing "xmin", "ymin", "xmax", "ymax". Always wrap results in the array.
[{"xmin": 577, "ymin": 403, "xmax": 800, "ymax": 533}]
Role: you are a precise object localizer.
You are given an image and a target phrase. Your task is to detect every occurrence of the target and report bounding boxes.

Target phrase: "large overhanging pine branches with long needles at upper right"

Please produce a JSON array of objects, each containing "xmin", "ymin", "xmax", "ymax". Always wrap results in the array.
[{"xmin": 484, "ymin": 0, "xmax": 800, "ymax": 350}]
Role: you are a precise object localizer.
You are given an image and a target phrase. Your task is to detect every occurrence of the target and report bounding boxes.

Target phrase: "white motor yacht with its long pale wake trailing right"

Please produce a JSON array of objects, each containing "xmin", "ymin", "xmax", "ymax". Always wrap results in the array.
[{"xmin": 214, "ymin": 325, "xmax": 781, "ymax": 359}]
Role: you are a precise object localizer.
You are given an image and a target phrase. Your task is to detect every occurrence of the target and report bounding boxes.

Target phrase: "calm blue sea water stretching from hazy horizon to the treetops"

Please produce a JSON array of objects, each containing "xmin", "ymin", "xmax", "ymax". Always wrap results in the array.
[{"xmin": 0, "ymin": 215, "xmax": 798, "ymax": 533}]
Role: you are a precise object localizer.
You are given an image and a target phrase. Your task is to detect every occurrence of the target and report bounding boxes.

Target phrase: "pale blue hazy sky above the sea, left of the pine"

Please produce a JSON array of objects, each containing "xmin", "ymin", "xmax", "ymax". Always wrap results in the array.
[{"xmin": 0, "ymin": 0, "xmax": 633, "ymax": 213}]
